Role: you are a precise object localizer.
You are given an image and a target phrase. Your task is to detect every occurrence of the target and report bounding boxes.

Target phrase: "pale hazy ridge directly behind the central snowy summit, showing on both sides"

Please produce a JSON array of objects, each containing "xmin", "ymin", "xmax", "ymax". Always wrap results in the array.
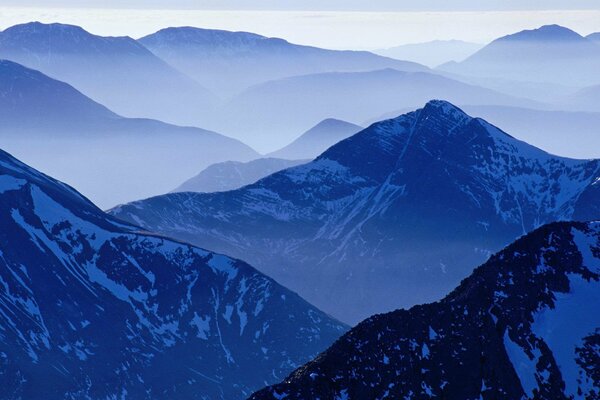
[{"xmin": 364, "ymin": 105, "xmax": 600, "ymax": 158}]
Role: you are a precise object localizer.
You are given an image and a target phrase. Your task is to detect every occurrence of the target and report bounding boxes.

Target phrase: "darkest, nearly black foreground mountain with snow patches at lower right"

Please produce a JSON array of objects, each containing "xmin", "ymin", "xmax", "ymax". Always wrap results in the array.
[{"xmin": 250, "ymin": 223, "xmax": 600, "ymax": 400}]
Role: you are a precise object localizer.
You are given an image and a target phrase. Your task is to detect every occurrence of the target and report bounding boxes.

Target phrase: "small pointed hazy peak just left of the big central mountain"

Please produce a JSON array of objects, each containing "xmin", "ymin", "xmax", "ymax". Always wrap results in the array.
[{"xmin": 269, "ymin": 118, "xmax": 364, "ymax": 160}]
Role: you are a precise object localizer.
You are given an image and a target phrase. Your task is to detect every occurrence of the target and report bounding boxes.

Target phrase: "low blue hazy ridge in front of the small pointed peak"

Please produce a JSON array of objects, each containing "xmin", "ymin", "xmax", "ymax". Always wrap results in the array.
[{"xmin": 173, "ymin": 158, "xmax": 309, "ymax": 193}]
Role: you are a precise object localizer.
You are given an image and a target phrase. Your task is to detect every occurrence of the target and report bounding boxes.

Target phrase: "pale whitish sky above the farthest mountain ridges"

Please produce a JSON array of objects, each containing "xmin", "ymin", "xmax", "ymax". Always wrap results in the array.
[{"xmin": 0, "ymin": 0, "xmax": 600, "ymax": 49}]
